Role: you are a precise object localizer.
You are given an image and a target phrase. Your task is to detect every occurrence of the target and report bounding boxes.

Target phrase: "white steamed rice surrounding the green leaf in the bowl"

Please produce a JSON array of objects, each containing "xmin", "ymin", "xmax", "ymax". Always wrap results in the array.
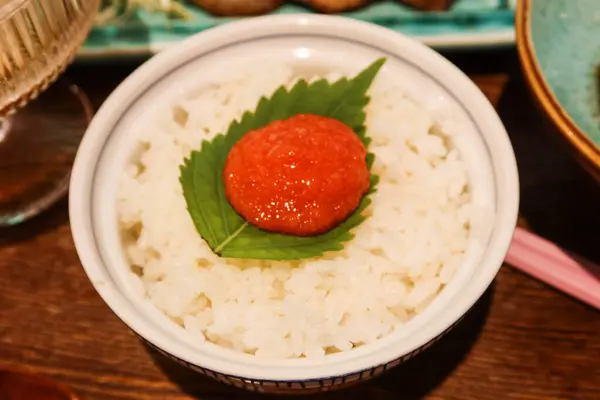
[{"xmin": 118, "ymin": 64, "xmax": 473, "ymax": 358}]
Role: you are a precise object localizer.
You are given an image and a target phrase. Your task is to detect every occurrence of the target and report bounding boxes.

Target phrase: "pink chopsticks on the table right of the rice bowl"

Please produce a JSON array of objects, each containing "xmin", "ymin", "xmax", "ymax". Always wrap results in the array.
[{"xmin": 506, "ymin": 228, "xmax": 600, "ymax": 309}]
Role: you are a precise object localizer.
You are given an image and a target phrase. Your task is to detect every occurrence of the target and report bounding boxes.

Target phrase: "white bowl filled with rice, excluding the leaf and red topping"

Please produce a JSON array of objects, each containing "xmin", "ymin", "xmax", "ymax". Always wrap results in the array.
[{"xmin": 69, "ymin": 14, "xmax": 519, "ymax": 393}]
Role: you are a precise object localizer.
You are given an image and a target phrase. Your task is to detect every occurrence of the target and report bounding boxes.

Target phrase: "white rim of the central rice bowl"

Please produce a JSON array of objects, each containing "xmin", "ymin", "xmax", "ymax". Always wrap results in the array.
[{"xmin": 69, "ymin": 14, "xmax": 519, "ymax": 382}]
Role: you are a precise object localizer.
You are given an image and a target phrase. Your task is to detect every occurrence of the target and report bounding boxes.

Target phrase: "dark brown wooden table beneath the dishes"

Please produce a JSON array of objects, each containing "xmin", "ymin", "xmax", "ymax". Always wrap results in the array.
[{"xmin": 0, "ymin": 50, "xmax": 600, "ymax": 400}]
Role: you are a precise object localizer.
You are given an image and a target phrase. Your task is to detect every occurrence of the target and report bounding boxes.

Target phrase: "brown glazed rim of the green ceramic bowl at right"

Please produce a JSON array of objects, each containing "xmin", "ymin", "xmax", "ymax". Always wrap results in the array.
[{"xmin": 515, "ymin": 0, "xmax": 600, "ymax": 168}]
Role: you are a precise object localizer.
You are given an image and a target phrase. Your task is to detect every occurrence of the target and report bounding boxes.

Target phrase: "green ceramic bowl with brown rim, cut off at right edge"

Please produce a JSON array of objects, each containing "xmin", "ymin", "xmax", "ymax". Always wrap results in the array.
[{"xmin": 516, "ymin": 0, "xmax": 600, "ymax": 181}]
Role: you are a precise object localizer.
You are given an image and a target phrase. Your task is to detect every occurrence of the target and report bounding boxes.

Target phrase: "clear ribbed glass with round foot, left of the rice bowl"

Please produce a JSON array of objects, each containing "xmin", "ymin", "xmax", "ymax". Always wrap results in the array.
[{"xmin": 0, "ymin": 0, "xmax": 100, "ymax": 226}]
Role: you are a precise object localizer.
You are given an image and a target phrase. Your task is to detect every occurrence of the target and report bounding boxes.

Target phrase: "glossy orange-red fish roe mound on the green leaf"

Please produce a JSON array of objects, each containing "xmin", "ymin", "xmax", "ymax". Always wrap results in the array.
[{"xmin": 223, "ymin": 114, "xmax": 370, "ymax": 236}]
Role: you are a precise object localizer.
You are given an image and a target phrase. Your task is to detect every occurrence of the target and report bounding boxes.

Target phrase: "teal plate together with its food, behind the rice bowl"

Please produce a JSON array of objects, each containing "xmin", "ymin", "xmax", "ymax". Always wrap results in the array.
[{"xmin": 79, "ymin": 0, "xmax": 516, "ymax": 60}]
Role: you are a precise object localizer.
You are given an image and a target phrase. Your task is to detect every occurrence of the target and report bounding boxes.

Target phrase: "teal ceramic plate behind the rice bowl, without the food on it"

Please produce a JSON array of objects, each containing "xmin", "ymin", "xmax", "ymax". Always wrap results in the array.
[{"xmin": 79, "ymin": 0, "xmax": 516, "ymax": 59}]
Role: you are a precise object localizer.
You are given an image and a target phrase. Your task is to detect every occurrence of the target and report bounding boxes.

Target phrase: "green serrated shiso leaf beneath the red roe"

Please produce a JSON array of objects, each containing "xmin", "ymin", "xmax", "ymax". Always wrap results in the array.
[{"xmin": 180, "ymin": 58, "xmax": 386, "ymax": 260}]
